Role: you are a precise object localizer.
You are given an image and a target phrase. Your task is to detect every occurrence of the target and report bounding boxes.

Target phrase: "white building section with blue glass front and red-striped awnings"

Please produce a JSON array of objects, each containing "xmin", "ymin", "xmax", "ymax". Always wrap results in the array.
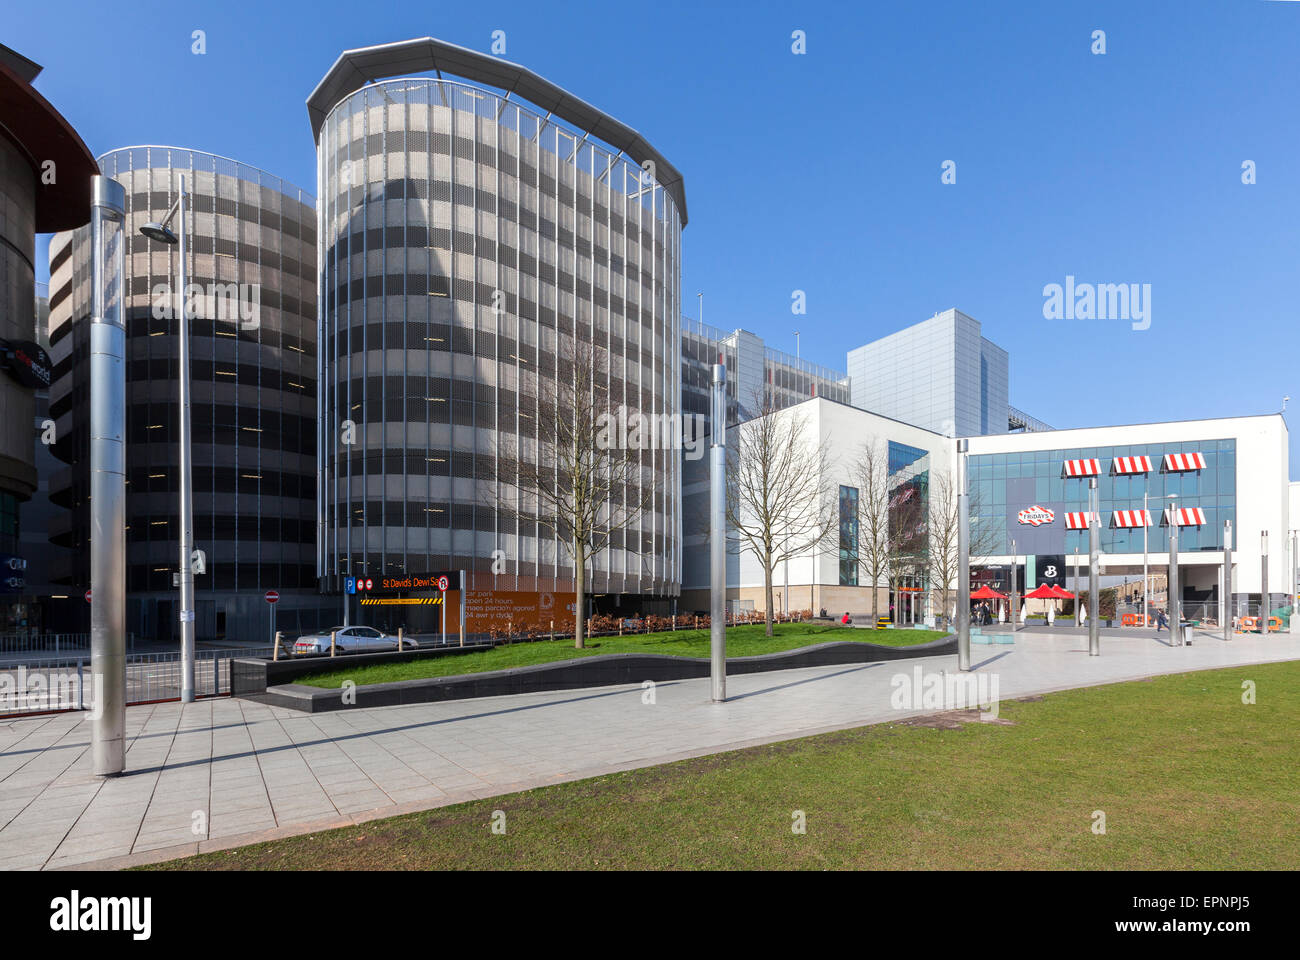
[{"xmin": 969, "ymin": 414, "xmax": 1300, "ymax": 618}]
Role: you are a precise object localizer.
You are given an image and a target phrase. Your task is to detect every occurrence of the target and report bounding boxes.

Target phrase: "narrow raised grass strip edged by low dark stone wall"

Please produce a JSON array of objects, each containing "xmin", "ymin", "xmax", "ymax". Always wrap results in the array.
[{"xmin": 295, "ymin": 623, "xmax": 948, "ymax": 687}]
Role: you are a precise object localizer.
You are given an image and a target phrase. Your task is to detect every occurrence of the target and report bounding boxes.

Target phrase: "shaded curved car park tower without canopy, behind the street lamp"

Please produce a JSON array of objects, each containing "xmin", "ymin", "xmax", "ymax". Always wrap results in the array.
[{"xmin": 49, "ymin": 147, "xmax": 320, "ymax": 639}]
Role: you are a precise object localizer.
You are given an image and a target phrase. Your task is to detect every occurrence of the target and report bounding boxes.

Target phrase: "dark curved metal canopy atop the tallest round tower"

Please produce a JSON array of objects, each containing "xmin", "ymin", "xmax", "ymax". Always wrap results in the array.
[{"xmin": 307, "ymin": 36, "xmax": 686, "ymax": 226}]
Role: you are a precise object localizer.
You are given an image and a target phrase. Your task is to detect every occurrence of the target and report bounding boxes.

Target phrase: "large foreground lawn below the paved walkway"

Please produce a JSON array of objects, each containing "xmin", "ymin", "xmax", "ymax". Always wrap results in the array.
[{"xmin": 143, "ymin": 663, "xmax": 1300, "ymax": 870}]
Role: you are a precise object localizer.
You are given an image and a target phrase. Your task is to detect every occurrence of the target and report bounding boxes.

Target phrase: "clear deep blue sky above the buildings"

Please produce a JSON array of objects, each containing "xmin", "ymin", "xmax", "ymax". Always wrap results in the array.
[{"xmin": 10, "ymin": 0, "xmax": 1300, "ymax": 476}]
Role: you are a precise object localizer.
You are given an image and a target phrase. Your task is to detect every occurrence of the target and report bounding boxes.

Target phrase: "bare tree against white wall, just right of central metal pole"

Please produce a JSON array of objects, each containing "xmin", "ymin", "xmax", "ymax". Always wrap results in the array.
[{"xmin": 727, "ymin": 388, "xmax": 839, "ymax": 636}]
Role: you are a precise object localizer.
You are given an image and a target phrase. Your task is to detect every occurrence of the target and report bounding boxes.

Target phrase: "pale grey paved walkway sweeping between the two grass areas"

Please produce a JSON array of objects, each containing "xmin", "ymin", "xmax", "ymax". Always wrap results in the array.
[{"xmin": 0, "ymin": 631, "xmax": 1300, "ymax": 869}]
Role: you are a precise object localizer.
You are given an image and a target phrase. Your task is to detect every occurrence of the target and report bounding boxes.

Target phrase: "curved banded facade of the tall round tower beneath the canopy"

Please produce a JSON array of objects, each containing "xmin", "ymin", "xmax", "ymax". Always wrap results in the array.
[{"xmin": 317, "ymin": 79, "xmax": 681, "ymax": 596}]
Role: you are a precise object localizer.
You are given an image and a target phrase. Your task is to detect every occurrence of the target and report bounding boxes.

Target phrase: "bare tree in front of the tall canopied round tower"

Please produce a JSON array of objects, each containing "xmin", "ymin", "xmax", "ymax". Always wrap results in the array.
[{"xmin": 498, "ymin": 337, "xmax": 655, "ymax": 649}]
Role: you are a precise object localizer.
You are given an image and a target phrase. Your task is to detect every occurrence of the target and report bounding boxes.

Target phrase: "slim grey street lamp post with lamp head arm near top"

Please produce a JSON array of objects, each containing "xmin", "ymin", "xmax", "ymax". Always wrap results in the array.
[{"xmin": 140, "ymin": 176, "xmax": 194, "ymax": 704}]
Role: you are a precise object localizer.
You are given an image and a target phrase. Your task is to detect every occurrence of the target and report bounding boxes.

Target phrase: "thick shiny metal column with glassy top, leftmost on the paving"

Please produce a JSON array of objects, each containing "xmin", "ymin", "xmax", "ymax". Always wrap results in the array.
[{"xmin": 90, "ymin": 177, "xmax": 126, "ymax": 777}]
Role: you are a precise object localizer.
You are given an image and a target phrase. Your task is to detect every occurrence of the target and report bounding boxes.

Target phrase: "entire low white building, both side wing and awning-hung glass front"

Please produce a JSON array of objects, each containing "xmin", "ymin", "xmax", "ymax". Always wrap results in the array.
[{"xmin": 680, "ymin": 398, "xmax": 1300, "ymax": 620}]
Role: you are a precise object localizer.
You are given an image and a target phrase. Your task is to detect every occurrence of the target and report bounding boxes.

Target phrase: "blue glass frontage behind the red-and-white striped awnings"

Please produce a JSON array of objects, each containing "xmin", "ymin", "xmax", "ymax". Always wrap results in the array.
[{"xmin": 970, "ymin": 438, "xmax": 1236, "ymax": 555}]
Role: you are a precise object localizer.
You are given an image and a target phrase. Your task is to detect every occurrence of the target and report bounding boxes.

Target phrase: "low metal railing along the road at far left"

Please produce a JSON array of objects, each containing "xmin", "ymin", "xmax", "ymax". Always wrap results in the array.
[{"xmin": 0, "ymin": 647, "xmax": 272, "ymax": 717}]
